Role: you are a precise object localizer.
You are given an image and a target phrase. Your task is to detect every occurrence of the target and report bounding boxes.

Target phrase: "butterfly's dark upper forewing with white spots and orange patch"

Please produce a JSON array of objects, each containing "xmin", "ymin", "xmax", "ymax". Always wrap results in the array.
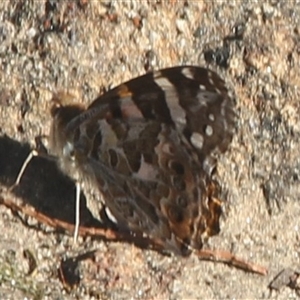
[{"xmin": 84, "ymin": 66, "xmax": 235, "ymax": 158}]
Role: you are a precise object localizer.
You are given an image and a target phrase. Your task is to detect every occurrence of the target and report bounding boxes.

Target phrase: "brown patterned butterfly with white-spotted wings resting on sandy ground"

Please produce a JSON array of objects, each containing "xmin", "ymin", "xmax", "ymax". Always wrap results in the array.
[{"xmin": 50, "ymin": 66, "xmax": 235, "ymax": 256}]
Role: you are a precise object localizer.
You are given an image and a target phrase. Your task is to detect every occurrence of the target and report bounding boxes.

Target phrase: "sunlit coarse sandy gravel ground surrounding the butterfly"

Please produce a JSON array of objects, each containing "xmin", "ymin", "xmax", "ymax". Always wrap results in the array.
[{"xmin": 0, "ymin": 0, "xmax": 300, "ymax": 299}]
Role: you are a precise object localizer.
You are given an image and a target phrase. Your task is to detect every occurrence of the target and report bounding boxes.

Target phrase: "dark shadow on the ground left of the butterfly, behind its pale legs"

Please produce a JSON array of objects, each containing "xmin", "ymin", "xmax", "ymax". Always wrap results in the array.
[{"xmin": 0, "ymin": 136, "xmax": 103, "ymax": 227}]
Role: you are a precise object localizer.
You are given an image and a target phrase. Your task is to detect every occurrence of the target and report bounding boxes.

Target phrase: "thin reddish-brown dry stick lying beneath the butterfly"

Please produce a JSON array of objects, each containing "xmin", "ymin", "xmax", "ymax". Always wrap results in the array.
[{"xmin": 0, "ymin": 197, "xmax": 267, "ymax": 275}]
